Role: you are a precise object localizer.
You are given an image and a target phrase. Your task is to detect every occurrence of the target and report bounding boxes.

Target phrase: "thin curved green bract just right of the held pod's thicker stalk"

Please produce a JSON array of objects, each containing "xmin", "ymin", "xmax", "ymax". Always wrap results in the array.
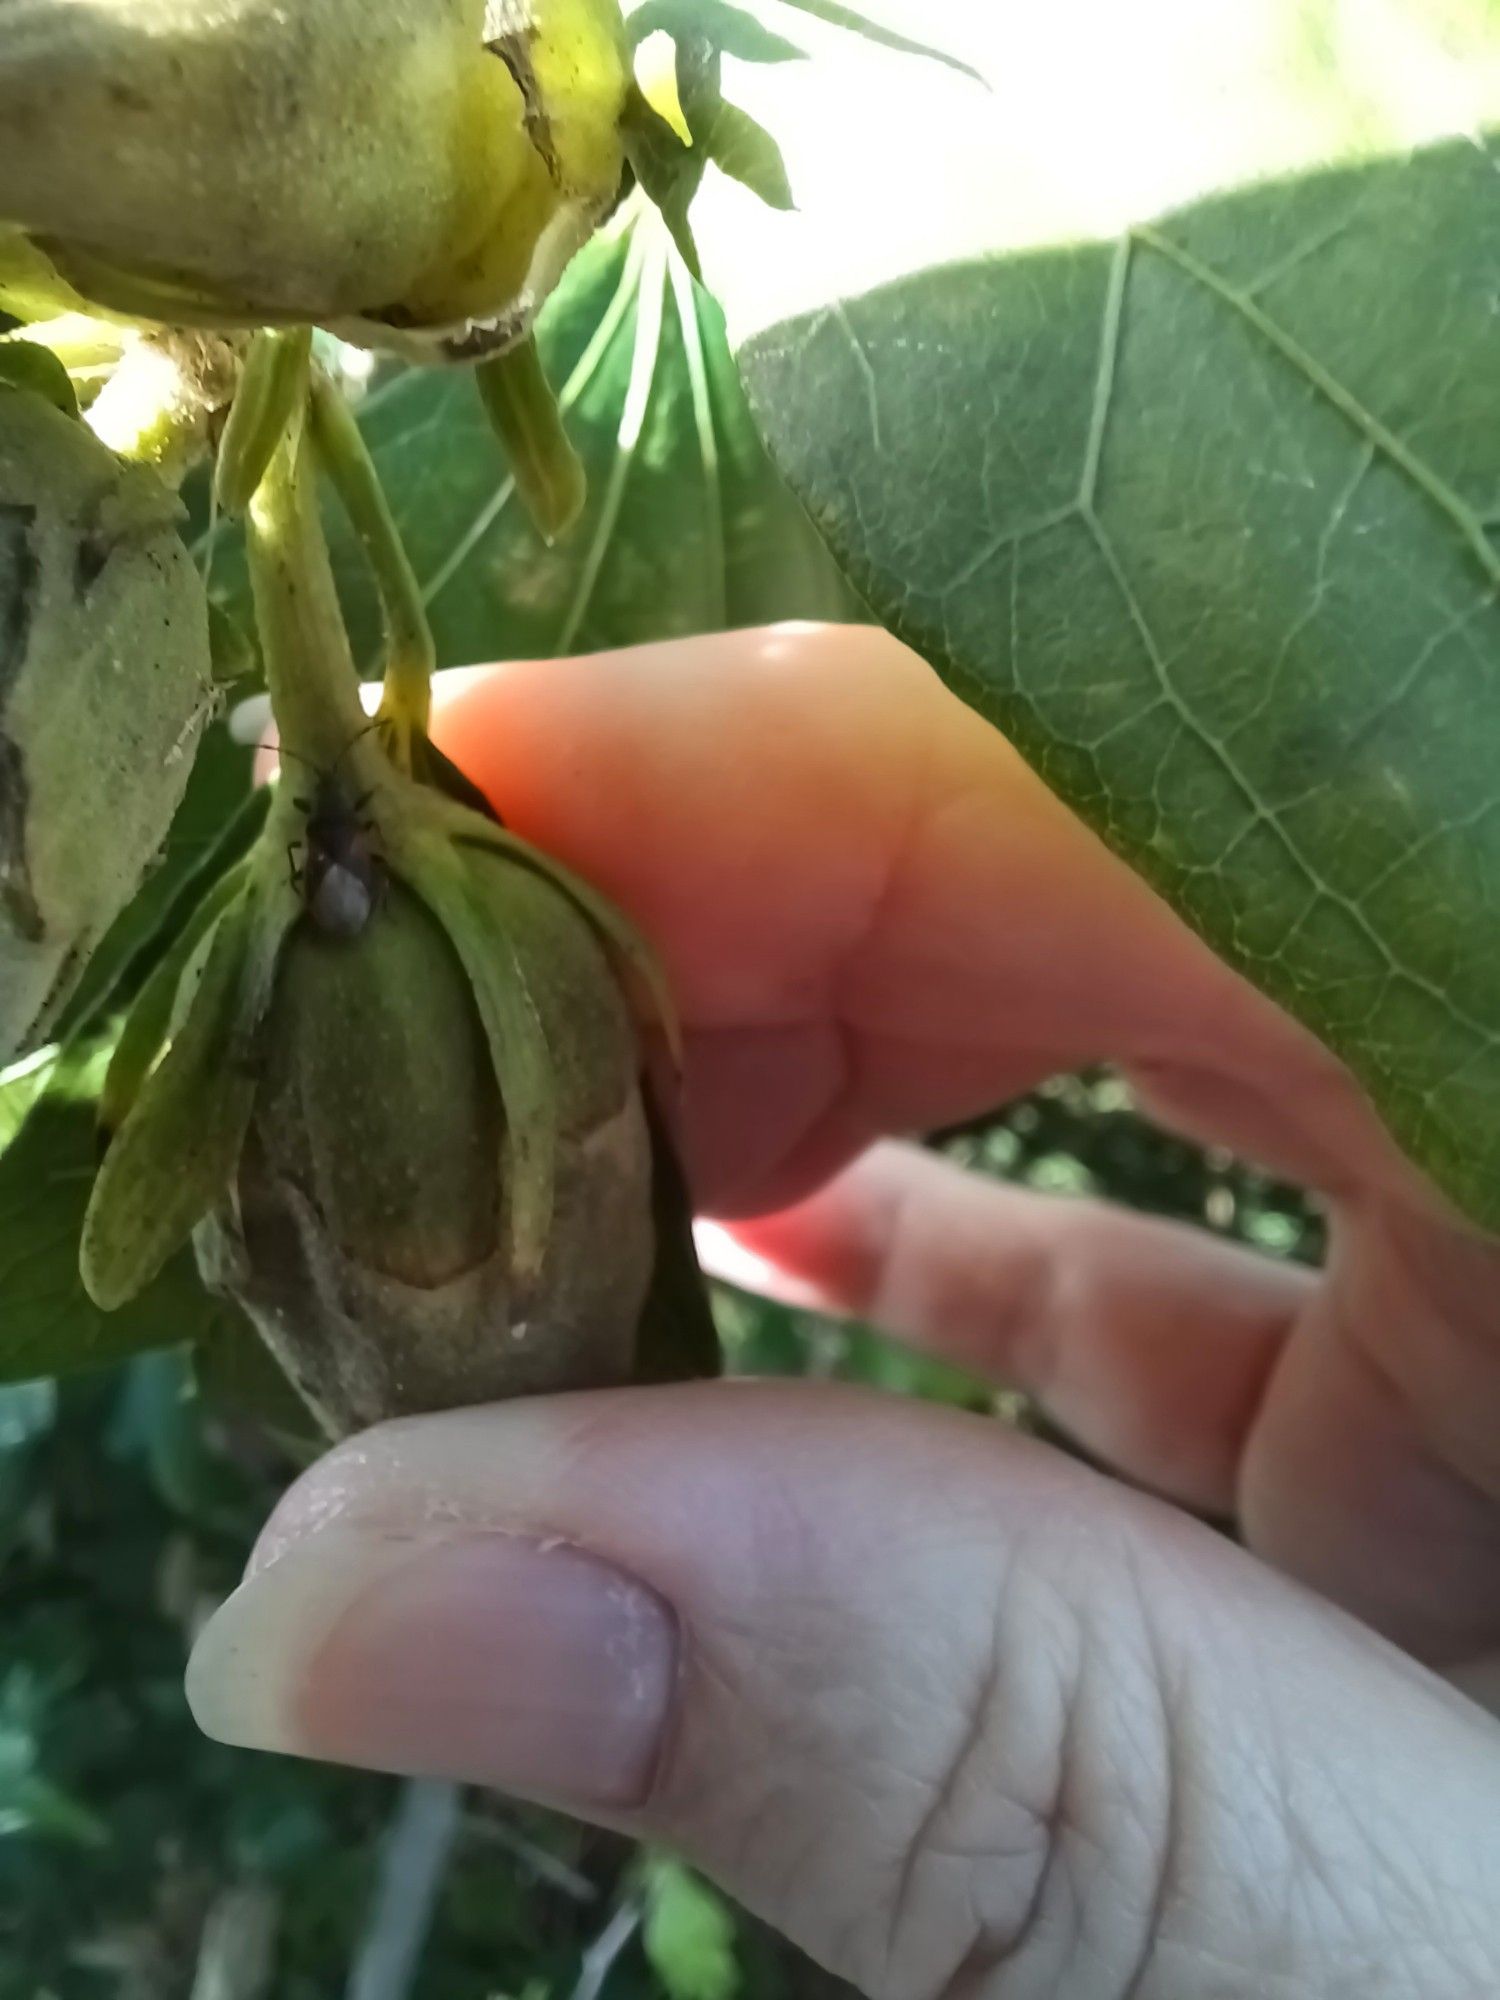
[{"xmin": 310, "ymin": 376, "xmax": 438, "ymax": 742}]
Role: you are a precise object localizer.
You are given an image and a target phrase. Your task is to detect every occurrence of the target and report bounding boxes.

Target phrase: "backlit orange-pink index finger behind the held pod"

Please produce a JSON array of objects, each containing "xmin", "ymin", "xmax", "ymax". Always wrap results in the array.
[{"xmin": 436, "ymin": 626, "xmax": 1388, "ymax": 1212}]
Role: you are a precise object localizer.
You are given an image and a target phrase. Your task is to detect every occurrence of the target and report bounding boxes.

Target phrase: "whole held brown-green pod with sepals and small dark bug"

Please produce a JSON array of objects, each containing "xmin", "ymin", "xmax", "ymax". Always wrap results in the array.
[{"xmin": 82, "ymin": 738, "xmax": 716, "ymax": 1436}]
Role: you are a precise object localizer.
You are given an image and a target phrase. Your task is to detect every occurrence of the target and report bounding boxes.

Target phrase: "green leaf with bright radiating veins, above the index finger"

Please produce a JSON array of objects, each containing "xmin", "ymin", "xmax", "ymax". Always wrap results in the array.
[{"xmin": 326, "ymin": 212, "xmax": 868, "ymax": 666}]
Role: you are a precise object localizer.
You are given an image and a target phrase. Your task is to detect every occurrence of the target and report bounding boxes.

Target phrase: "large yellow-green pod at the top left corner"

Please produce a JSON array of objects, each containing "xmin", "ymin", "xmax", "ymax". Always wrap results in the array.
[{"xmin": 0, "ymin": 0, "xmax": 630, "ymax": 352}]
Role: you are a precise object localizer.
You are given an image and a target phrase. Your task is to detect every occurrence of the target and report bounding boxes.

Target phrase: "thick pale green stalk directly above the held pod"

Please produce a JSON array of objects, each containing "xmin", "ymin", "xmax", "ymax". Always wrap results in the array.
[{"xmin": 246, "ymin": 424, "xmax": 366, "ymax": 772}]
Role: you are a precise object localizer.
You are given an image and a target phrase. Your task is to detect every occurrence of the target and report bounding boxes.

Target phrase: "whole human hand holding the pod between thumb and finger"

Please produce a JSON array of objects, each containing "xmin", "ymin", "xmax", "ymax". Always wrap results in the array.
[{"xmin": 190, "ymin": 630, "xmax": 1500, "ymax": 2000}]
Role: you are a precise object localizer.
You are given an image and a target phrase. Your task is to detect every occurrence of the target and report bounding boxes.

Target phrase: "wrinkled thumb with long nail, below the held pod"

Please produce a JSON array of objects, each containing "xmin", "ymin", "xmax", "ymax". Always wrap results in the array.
[{"xmin": 188, "ymin": 1384, "xmax": 1500, "ymax": 2000}]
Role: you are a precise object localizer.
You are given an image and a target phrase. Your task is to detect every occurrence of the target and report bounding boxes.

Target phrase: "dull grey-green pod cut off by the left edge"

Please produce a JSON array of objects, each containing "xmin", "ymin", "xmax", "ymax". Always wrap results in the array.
[{"xmin": 0, "ymin": 386, "xmax": 214, "ymax": 1060}]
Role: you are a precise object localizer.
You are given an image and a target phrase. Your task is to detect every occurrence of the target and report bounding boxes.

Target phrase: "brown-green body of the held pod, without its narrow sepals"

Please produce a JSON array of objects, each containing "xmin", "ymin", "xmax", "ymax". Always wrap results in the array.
[{"xmin": 196, "ymin": 854, "xmax": 654, "ymax": 1434}]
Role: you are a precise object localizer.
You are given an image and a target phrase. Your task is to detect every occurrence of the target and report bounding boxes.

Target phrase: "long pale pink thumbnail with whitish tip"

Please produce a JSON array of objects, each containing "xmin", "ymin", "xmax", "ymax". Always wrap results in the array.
[{"xmin": 188, "ymin": 1524, "xmax": 678, "ymax": 1810}]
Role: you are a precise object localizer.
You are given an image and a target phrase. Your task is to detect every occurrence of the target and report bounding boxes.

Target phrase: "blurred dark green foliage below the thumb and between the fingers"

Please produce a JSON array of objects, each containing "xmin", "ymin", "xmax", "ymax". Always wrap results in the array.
[{"xmin": 0, "ymin": 1072, "xmax": 1322, "ymax": 2000}]
